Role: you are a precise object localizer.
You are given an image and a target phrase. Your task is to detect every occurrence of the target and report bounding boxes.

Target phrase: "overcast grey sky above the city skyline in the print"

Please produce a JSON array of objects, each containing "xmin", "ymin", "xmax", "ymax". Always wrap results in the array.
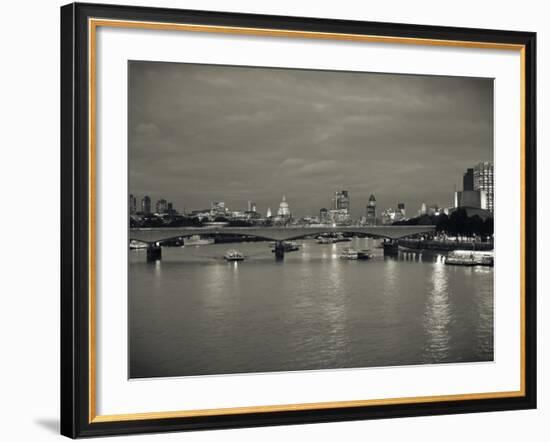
[{"xmin": 129, "ymin": 61, "xmax": 493, "ymax": 217}]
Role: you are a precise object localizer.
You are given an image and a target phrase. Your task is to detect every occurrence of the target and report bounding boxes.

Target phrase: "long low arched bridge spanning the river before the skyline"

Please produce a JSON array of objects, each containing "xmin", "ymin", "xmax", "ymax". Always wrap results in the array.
[{"xmin": 129, "ymin": 225, "xmax": 435, "ymax": 260}]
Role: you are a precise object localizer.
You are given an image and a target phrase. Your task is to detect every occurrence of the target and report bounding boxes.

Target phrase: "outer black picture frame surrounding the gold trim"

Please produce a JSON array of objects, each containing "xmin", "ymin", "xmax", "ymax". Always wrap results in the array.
[{"xmin": 61, "ymin": 3, "xmax": 537, "ymax": 438}]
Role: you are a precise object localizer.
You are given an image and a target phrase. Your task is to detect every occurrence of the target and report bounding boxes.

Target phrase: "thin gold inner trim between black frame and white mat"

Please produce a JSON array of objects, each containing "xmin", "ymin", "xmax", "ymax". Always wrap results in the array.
[{"xmin": 88, "ymin": 18, "xmax": 526, "ymax": 423}]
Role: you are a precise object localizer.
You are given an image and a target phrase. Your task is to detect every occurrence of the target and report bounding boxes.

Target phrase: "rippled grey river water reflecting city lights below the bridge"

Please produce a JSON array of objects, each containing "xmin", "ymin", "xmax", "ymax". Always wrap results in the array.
[{"xmin": 129, "ymin": 238, "xmax": 493, "ymax": 378}]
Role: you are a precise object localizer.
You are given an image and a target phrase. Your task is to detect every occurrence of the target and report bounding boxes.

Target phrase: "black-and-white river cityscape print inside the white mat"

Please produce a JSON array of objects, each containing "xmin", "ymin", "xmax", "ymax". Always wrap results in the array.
[{"xmin": 128, "ymin": 60, "xmax": 495, "ymax": 378}]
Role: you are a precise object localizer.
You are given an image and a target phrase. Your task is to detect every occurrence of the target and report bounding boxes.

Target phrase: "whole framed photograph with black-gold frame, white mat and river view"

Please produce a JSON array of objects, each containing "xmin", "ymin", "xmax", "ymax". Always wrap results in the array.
[{"xmin": 61, "ymin": 4, "xmax": 536, "ymax": 438}]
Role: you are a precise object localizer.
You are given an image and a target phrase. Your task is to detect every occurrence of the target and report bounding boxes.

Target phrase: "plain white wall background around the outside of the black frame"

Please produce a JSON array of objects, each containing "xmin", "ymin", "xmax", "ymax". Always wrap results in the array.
[{"xmin": 0, "ymin": 0, "xmax": 550, "ymax": 442}]
